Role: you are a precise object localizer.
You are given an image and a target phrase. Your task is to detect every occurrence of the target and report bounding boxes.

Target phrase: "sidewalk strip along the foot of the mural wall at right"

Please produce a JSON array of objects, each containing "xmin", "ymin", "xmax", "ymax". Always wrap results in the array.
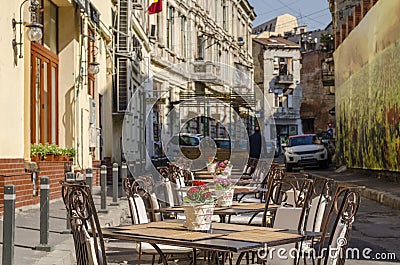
[{"xmin": 308, "ymin": 167, "xmax": 400, "ymax": 210}]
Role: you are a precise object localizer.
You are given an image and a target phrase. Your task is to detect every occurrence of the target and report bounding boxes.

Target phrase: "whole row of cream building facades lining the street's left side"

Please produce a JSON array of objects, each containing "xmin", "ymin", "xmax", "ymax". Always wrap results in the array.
[{"xmin": 0, "ymin": 0, "xmax": 255, "ymax": 207}]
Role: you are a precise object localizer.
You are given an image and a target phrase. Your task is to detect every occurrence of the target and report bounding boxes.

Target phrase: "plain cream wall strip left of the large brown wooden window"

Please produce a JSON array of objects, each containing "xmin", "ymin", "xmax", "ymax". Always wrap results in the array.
[{"xmin": 0, "ymin": 1, "xmax": 29, "ymax": 158}]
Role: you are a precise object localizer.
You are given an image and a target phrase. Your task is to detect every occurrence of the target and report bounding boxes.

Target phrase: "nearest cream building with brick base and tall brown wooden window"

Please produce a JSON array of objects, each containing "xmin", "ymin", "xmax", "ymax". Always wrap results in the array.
[{"xmin": 0, "ymin": 0, "xmax": 113, "ymax": 211}]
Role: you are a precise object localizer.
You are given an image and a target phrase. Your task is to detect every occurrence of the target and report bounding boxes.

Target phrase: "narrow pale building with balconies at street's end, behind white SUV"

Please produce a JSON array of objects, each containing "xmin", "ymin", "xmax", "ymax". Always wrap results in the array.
[{"xmin": 253, "ymin": 37, "xmax": 303, "ymax": 148}]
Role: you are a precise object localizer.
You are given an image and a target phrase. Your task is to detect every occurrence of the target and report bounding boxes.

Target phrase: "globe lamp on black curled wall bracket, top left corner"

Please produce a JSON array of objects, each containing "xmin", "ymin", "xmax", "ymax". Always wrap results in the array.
[{"xmin": 12, "ymin": 0, "xmax": 43, "ymax": 58}]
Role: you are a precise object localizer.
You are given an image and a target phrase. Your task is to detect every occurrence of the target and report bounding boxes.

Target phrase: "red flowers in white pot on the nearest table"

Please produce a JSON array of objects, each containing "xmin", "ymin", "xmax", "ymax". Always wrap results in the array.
[{"xmin": 183, "ymin": 183, "xmax": 214, "ymax": 231}]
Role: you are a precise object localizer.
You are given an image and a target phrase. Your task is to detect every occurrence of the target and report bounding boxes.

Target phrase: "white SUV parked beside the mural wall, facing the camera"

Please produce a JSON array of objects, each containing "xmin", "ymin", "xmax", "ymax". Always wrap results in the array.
[{"xmin": 285, "ymin": 134, "xmax": 329, "ymax": 171}]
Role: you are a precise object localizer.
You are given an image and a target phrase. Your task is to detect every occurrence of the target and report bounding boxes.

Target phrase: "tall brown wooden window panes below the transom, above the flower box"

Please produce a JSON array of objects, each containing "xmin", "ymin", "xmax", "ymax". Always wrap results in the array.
[{"xmin": 31, "ymin": 42, "xmax": 58, "ymax": 143}]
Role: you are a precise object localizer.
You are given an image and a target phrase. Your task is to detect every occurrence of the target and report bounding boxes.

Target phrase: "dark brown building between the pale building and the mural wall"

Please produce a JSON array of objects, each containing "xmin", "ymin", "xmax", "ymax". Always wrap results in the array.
[{"xmin": 287, "ymin": 23, "xmax": 335, "ymax": 134}]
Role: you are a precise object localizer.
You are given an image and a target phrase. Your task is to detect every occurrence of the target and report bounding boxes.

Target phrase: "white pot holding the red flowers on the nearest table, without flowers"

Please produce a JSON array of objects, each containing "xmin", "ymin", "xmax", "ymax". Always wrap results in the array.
[{"xmin": 183, "ymin": 204, "xmax": 214, "ymax": 231}]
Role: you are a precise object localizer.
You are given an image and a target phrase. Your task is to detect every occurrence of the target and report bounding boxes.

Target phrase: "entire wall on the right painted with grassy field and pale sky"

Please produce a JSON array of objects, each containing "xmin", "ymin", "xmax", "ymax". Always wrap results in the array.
[{"xmin": 334, "ymin": 0, "xmax": 400, "ymax": 172}]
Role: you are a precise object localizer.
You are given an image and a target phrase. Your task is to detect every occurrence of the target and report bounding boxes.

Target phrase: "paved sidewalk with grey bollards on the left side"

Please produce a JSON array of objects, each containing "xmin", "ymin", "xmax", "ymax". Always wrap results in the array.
[{"xmin": 0, "ymin": 187, "xmax": 131, "ymax": 265}]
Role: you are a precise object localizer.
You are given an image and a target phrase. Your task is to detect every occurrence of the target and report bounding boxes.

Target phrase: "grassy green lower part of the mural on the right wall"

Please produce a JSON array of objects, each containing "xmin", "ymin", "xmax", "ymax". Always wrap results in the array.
[{"xmin": 336, "ymin": 39, "xmax": 400, "ymax": 171}]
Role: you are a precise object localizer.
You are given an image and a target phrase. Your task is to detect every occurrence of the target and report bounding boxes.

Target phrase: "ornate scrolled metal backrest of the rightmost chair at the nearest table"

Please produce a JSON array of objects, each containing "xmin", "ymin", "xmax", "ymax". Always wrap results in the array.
[{"xmin": 317, "ymin": 184, "xmax": 365, "ymax": 265}]
